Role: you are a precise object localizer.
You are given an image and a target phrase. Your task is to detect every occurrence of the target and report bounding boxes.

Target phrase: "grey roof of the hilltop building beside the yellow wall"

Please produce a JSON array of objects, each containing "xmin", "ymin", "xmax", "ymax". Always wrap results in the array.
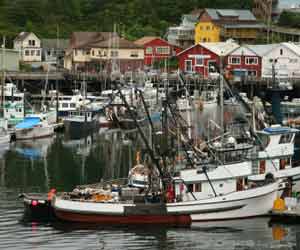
[{"xmin": 204, "ymin": 9, "xmax": 256, "ymax": 21}]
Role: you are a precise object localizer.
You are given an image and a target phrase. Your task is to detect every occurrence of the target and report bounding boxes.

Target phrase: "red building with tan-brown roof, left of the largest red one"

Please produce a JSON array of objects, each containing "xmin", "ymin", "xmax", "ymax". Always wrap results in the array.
[{"xmin": 134, "ymin": 36, "xmax": 182, "ymax": 66}]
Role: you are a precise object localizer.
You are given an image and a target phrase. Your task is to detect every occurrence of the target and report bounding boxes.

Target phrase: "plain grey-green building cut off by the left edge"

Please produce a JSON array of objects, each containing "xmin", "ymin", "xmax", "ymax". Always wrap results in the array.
[{"xmin": 0, "ymin": 49, "xmax": 20, "ymax": 71}]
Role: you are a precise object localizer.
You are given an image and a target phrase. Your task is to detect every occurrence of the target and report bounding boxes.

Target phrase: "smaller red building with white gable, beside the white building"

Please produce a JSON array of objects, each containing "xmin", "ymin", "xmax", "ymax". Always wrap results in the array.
[{"xmin": 226, "ymin": 46, "xmax": 262, "ymax": 80}]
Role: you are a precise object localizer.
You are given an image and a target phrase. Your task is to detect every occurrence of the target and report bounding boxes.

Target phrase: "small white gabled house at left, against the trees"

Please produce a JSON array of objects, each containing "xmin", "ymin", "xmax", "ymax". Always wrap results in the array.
[{"xmin": 14, "ymin": 32, "xmax": 42, "ymax": 62}]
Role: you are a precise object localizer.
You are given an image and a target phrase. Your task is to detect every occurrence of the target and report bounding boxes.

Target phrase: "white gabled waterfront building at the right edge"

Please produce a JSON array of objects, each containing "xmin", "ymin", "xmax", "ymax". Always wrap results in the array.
[{"xmin": 248, "ymin": 42, "xmax": 300, "ymax": 79}]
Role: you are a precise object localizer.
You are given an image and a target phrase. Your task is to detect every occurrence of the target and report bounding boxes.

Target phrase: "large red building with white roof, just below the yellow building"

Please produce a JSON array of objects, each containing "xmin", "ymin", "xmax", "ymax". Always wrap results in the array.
[{"xmin": 177, "ymin": 41, "xmax": 239, "ymax": 78}]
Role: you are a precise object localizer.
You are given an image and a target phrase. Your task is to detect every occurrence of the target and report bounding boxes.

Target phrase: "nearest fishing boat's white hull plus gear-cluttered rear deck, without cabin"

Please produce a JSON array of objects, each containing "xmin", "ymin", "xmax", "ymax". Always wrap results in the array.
[{"xmin": 52, "ymin": 178, "xmax": 278, "ymax": 225}]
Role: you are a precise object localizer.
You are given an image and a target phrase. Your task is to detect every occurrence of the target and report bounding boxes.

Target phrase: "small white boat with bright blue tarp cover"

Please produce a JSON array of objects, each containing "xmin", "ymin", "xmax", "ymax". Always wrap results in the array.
[{"xmin": 15, "ymin": 114, "xmax": 54, "ymax": 140}]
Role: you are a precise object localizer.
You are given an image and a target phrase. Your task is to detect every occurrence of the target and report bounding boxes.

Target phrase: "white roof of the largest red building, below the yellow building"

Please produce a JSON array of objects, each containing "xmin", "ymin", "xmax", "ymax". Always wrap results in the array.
[{"xmin": 178, "ymin": 40, "xmax": 239, "ymax": 56}]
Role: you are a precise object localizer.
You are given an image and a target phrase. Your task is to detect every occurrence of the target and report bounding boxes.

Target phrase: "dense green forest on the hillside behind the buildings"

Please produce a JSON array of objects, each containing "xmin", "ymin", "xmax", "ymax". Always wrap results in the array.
[{"xmin": 0, "ymin": 0, "xmax": 252, "ymax": 41}]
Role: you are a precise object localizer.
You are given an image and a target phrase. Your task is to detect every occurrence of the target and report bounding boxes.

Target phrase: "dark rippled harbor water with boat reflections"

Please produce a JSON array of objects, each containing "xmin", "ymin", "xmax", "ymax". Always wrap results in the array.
[{"xmin": 0, "ymin": 104, "xmax": 300, "ymax": 250}]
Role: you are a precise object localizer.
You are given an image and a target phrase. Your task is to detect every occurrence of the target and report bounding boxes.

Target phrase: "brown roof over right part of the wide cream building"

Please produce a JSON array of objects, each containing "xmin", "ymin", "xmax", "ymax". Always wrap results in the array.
[{"xmin": 88, "ymin": 38, "xmax": 143, "ymax": 49}]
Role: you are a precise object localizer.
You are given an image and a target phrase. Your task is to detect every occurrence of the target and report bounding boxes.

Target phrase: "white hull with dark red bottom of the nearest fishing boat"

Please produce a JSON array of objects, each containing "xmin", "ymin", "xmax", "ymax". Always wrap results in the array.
[{"xmin": 53, "ymin": 183, "xmax": 278, "ymax": 225}]
